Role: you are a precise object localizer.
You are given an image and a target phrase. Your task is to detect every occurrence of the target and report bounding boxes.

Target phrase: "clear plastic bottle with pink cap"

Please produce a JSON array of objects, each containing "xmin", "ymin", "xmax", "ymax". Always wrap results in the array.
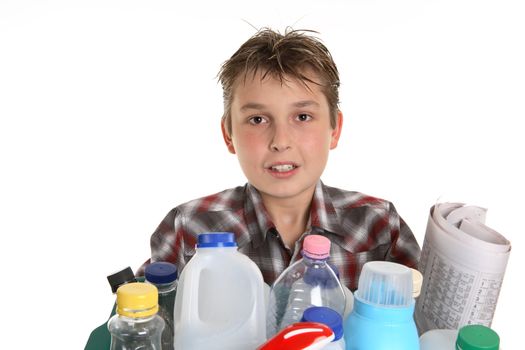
[{"xmin": 266, "ymin": 235, "xmax": 346, "ymax": 338}]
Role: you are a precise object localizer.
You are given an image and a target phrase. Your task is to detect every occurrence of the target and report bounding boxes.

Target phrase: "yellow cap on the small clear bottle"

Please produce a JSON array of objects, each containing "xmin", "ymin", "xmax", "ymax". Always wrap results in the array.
[{"xmin": 117, "ymin": 282, "xmax": 159, "ymax": 318}]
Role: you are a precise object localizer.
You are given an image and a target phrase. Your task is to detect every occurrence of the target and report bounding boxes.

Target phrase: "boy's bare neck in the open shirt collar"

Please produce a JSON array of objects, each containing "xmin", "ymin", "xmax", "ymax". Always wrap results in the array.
[{"xmin": 261, "ymin": 188, "xmax": 315, "ymax": 249}]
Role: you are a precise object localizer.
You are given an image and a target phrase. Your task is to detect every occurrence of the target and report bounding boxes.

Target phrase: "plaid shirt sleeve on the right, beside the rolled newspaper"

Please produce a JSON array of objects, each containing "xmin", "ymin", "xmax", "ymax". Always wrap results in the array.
[{"xmin": 385, "ymin": 203, "xmax": 421, "ymax": 269}]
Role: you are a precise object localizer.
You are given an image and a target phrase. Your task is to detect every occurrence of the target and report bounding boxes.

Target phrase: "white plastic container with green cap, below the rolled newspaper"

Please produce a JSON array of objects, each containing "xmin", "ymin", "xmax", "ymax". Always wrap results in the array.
[{"xmin": 419, "ymin": 325, "xmax": 500, "ymax": 350}]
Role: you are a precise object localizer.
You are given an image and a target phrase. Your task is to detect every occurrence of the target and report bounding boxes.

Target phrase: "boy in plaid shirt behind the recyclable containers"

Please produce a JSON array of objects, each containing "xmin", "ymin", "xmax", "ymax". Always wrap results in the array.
[{"xmin": 138, "ymin": 29, "xmax": 420, "ymax": 291}]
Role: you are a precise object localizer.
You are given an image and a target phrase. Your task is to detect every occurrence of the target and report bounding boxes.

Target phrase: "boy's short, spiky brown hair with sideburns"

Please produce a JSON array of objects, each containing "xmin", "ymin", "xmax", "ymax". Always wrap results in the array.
[{"xmin": 218, "ymin": 28, "xmax": 339, "ymax": 134}]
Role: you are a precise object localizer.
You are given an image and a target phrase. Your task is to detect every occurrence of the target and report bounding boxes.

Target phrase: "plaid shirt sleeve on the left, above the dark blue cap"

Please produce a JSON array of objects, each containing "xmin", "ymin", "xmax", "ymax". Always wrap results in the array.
[{"xmin": 136, "ymin": 208, "xmax": 189, "ymax": 276}]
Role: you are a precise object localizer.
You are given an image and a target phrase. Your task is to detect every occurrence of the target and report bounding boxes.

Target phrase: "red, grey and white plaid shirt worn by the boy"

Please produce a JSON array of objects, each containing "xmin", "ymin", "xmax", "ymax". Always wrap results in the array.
[{"xmin": 137, "ymin": 181, "xmax": 420, "ymax": 291}]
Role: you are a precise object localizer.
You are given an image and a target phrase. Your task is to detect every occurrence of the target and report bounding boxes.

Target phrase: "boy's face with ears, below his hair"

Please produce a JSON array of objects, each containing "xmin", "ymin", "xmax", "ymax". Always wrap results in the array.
[{"xmin": 222, "ymin": 72, "xmax": 342, "ymax": 199}]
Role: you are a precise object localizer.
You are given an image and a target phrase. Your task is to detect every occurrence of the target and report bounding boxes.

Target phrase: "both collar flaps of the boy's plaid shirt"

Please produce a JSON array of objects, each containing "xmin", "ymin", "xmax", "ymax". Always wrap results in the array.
[{"xmin": 244, "ymin": 180, "xmax": 343, "ymax": 248}]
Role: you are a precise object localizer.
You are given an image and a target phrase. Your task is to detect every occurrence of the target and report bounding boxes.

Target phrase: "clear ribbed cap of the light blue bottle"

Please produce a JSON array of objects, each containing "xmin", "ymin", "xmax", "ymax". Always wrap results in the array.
[{"xmin": 356, "ymin": 261, "xmax": 413, "ymax": 306}]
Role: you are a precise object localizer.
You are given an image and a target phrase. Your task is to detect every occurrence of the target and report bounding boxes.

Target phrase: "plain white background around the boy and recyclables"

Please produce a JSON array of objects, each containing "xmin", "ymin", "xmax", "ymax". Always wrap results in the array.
[{"xmin": 0, "ymin": 0, "xmax": 525, "ymax": 350}]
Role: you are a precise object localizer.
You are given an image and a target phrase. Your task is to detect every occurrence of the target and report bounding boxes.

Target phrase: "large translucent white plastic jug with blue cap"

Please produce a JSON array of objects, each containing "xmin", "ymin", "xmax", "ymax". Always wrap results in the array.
[{"xmin": 174, "ymin": 232, "xmax": 266, "ymax": 350}]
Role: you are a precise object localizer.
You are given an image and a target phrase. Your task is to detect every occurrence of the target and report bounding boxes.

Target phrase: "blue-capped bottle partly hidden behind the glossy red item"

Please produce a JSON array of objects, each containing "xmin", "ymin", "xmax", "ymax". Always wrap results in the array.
[{"xmin": 301, "ymin": 306, "xmax": 345, "ymax": 350}]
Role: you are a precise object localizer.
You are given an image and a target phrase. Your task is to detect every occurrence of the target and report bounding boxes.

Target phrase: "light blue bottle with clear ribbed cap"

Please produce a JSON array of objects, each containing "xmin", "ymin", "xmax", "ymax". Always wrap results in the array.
[{"xmin": 344, "ymin": 261, "xmax": 419, "ymax": 350}]
